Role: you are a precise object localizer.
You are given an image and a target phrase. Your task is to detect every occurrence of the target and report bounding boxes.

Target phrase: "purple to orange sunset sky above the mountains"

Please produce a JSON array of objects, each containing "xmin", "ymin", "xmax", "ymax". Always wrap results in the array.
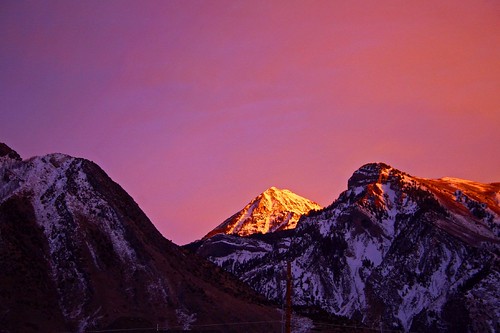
[{"xmin": 0, "ymin": 0, "xmax": 500, "ymax": 244}]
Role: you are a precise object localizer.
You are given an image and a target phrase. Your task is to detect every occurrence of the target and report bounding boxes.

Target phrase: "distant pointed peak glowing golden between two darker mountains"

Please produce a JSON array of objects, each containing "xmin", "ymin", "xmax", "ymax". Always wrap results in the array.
[{"xmin": 203, "ymin": 187, "xmax": 322, "ymax": 239}]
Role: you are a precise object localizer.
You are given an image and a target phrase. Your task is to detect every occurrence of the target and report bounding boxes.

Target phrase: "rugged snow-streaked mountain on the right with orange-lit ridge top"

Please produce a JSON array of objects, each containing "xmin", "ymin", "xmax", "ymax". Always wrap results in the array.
[{"xmin": 189, "ymin": 163, "xmax": 500, "ymax": 332}]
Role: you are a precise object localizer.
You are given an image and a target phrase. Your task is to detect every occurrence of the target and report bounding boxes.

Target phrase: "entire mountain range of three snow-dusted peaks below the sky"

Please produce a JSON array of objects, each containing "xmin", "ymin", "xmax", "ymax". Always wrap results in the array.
[{"xmin": 0, "ymin": 143, "xmax": 500, "ymax": 332}]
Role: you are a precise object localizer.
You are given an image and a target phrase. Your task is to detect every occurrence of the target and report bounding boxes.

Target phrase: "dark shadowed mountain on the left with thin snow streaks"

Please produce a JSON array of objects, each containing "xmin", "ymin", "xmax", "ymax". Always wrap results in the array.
[{"xmin": 0, "ymin": 144, "xmax": 281, "ymax": 332}]
